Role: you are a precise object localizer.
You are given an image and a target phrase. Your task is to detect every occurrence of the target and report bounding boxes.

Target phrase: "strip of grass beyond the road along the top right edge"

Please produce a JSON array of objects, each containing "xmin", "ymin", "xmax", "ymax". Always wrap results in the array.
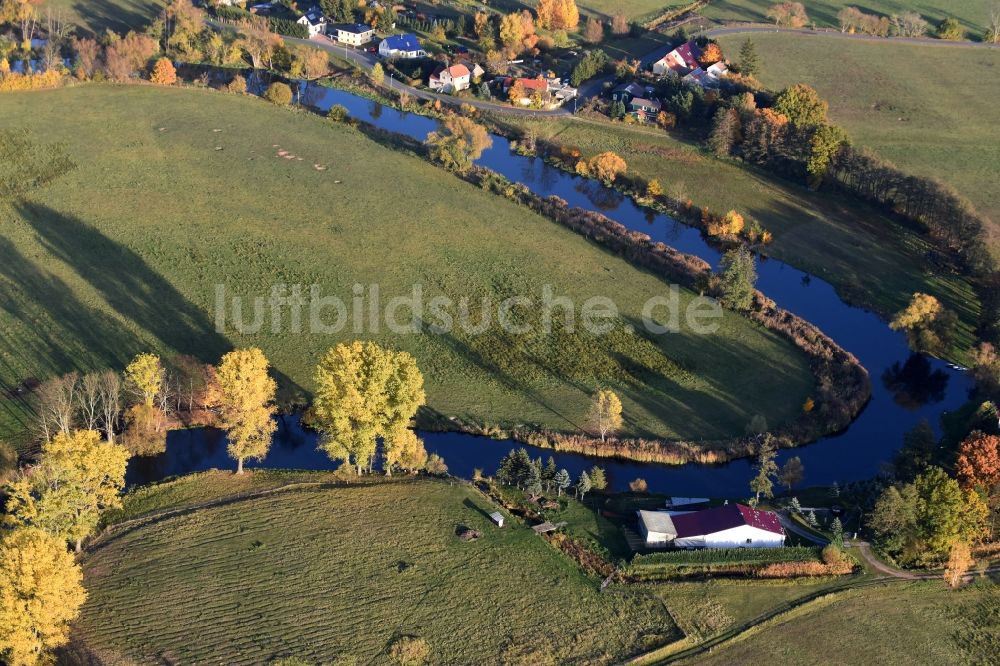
[{"xmin": 701, "ymin": 0, "xmax": 994, "ymax": 37}]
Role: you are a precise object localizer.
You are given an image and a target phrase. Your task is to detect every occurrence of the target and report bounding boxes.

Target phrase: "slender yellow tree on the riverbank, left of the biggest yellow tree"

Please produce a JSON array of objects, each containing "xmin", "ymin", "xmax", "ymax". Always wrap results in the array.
[{"xmin": 216, "ymin": 347, "xmax": 277, "ymax": 474}]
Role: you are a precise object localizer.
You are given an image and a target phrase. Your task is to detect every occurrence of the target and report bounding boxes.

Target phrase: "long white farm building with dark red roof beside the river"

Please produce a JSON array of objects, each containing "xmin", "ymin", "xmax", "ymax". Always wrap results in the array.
[{"xmin": 638, "ymin": 504, "xmax": 785, "ymax": 548}]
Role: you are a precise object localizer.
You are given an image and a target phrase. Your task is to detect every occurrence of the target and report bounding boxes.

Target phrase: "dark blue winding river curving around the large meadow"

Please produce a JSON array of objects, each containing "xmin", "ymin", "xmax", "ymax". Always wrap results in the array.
[{"xmin": 128, "ymin": 86, "xmax": 972, "ymax": 496}]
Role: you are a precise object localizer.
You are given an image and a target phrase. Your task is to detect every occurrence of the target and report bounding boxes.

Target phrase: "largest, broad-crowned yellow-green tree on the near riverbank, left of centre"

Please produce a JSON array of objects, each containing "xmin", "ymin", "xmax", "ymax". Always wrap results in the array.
[{"xmin": 313, "ymin": 341, "xmax": 426, "ymax": 474}]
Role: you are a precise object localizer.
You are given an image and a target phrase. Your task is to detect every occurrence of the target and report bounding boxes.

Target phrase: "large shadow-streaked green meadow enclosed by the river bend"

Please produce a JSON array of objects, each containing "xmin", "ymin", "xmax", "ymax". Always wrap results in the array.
[{"xmin": 0, "ymin": 86, "xmax": 812, "ymax": 446}]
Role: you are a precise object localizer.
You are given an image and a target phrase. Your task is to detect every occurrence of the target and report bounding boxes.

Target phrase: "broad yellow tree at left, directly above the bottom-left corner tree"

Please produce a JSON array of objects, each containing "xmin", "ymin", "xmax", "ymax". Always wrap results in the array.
[{"xmin": 7, "ymin": 430, "xmax": 129, "ymax": 552}]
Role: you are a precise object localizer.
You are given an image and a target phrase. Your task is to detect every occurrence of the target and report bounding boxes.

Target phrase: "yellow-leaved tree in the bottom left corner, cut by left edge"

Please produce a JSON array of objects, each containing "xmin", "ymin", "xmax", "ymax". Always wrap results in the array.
[{"xmin": 0, "ymin": 527, "xmax": 87, "ymax": 666}]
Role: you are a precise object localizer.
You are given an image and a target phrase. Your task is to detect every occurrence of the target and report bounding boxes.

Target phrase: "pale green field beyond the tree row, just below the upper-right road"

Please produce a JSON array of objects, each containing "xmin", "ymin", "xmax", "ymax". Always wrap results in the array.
[{"xmin": 719, "ymin": 34, "xmax": 1000, "ymax": 252}]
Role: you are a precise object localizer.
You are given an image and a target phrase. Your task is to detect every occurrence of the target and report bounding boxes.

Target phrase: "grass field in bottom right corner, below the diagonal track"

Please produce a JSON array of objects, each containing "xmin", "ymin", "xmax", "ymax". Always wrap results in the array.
[{"xmin": 686, "ymin": 581, "xmax": 1000, "ymax": 665}]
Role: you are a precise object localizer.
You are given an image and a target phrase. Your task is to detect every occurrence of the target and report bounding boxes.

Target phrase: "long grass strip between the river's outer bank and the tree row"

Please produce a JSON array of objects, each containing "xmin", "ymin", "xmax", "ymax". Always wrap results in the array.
[{"xmin": 500, "ymin": 121, "xmax": 979, "ymax": 358}]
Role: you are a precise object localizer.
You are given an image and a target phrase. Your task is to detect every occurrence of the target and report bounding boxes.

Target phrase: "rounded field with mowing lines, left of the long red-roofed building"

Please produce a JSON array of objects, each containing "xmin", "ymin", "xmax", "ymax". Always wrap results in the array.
[{"xmin": 74, "ymin": 479, "xmax": 679, "ymax": 665}]
